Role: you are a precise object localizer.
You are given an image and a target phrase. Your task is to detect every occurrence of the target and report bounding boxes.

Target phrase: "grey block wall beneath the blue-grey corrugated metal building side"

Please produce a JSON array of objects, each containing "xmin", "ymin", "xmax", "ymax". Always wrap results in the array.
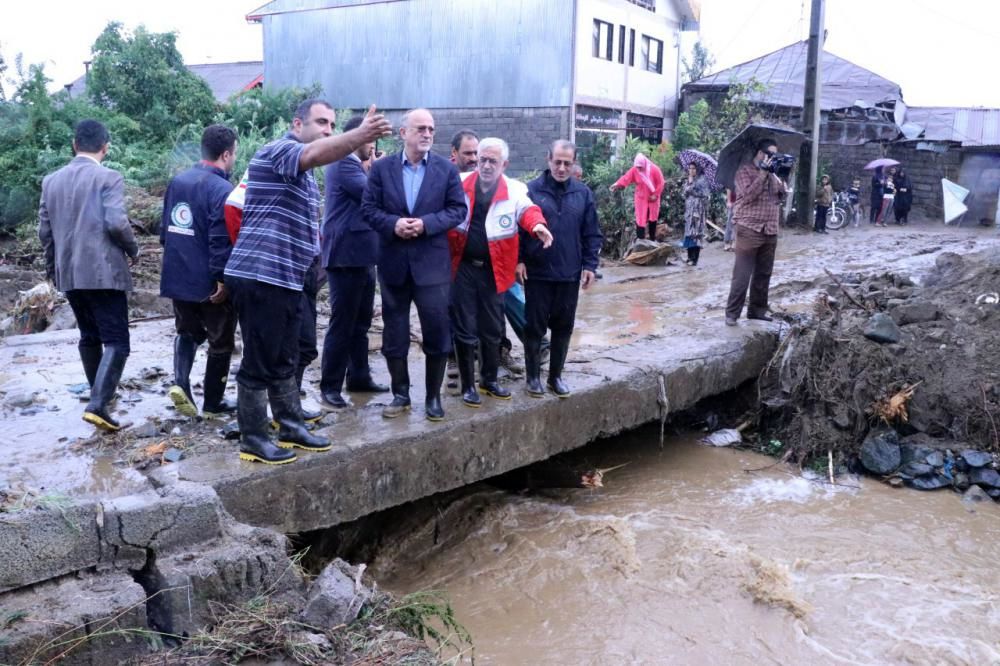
[{"xmin": 388, "ymin": 107, "xmax": 570, "ymax": 176}]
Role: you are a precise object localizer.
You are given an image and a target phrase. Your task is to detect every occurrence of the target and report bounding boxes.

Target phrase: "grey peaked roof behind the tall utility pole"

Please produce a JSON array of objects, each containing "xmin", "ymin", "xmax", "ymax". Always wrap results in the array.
[{"xmin": 684, "ymin": 41, "xmax": 903, "ymax": 110}]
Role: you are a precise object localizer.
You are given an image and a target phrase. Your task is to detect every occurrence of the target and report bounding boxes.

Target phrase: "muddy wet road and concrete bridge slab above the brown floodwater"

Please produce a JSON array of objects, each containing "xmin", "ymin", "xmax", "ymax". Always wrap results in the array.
[{"xmin": 0, "ymin": 219, "xmax": 998, "ymax": 660}]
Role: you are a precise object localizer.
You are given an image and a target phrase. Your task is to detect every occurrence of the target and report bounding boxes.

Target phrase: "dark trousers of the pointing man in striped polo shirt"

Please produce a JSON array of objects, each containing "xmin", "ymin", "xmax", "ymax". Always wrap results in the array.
[{"xmin": 226, "ymin": 276, "xmax": 305, "ymax": 390}]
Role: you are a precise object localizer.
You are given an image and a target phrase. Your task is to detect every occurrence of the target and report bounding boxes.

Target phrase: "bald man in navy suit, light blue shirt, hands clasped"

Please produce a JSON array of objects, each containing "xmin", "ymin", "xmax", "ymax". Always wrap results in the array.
[{"xmin": 361, "ymin": 109, "xmax": 468, "ymax": 421}]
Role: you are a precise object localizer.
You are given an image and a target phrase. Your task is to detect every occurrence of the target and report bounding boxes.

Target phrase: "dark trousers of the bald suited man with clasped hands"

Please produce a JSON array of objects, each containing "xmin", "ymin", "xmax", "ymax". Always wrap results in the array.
[{"xmin": 380, "ymin": 276, "xmax": 451, "ymax": 358}]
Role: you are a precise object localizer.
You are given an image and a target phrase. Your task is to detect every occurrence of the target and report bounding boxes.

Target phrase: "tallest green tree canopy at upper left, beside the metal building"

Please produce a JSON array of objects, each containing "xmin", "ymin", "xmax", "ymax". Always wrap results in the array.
[{"xmin": 87, "ymin": 22, "xmax": 217, "ymax": 140}]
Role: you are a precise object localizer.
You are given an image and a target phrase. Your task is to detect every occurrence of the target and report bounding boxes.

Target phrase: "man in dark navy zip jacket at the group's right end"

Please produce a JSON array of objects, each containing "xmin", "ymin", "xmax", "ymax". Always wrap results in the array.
[{"xmin": 517, "ymin": 141, "xmax": 603, "ymax": 398}]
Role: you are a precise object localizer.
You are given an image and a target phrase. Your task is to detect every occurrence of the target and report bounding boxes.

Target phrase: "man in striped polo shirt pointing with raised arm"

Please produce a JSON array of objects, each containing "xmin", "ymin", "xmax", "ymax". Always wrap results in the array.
[{"xmin": 225, "ymin": 99, "xmax": 392, "ymax": 464}]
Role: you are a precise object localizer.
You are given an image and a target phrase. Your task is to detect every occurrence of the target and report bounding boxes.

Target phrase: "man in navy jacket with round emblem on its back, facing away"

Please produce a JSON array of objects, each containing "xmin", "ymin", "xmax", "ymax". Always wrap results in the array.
[{"xmin": 160, "ymin": 125, "xmax": 236, "ymax": 416}]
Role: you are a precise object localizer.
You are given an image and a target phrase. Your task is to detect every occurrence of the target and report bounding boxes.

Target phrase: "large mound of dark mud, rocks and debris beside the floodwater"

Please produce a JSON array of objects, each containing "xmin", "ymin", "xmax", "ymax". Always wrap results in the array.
[{"xmin": 758, "ymin": 253, "xmax": 1000, "ymax": 498}]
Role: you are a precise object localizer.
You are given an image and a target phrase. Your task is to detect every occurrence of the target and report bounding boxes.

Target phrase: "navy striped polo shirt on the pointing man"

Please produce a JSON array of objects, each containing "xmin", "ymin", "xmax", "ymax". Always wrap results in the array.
[{"xmin": 226, "ymin": 132, "xmax": 320, "ymax": 291}]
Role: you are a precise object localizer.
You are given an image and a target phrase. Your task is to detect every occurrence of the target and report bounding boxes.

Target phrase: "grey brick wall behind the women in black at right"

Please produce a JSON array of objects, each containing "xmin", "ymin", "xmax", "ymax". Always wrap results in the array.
[{"xmin": 819, "ymin": 143, "xmax": 962, "ymax": 217}]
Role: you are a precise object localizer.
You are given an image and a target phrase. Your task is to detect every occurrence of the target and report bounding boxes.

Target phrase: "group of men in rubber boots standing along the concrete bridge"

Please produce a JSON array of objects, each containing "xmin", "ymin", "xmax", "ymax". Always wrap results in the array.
[{"xmin": 39, "ymin": 99, "xmax": 602, "ymax": 464}]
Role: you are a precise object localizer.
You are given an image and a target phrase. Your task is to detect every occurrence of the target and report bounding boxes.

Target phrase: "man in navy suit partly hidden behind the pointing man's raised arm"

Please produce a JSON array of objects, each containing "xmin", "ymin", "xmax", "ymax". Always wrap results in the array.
[{"xmin": 319, "ymin": 116, "xmax": 389, "ymax": 409}]
